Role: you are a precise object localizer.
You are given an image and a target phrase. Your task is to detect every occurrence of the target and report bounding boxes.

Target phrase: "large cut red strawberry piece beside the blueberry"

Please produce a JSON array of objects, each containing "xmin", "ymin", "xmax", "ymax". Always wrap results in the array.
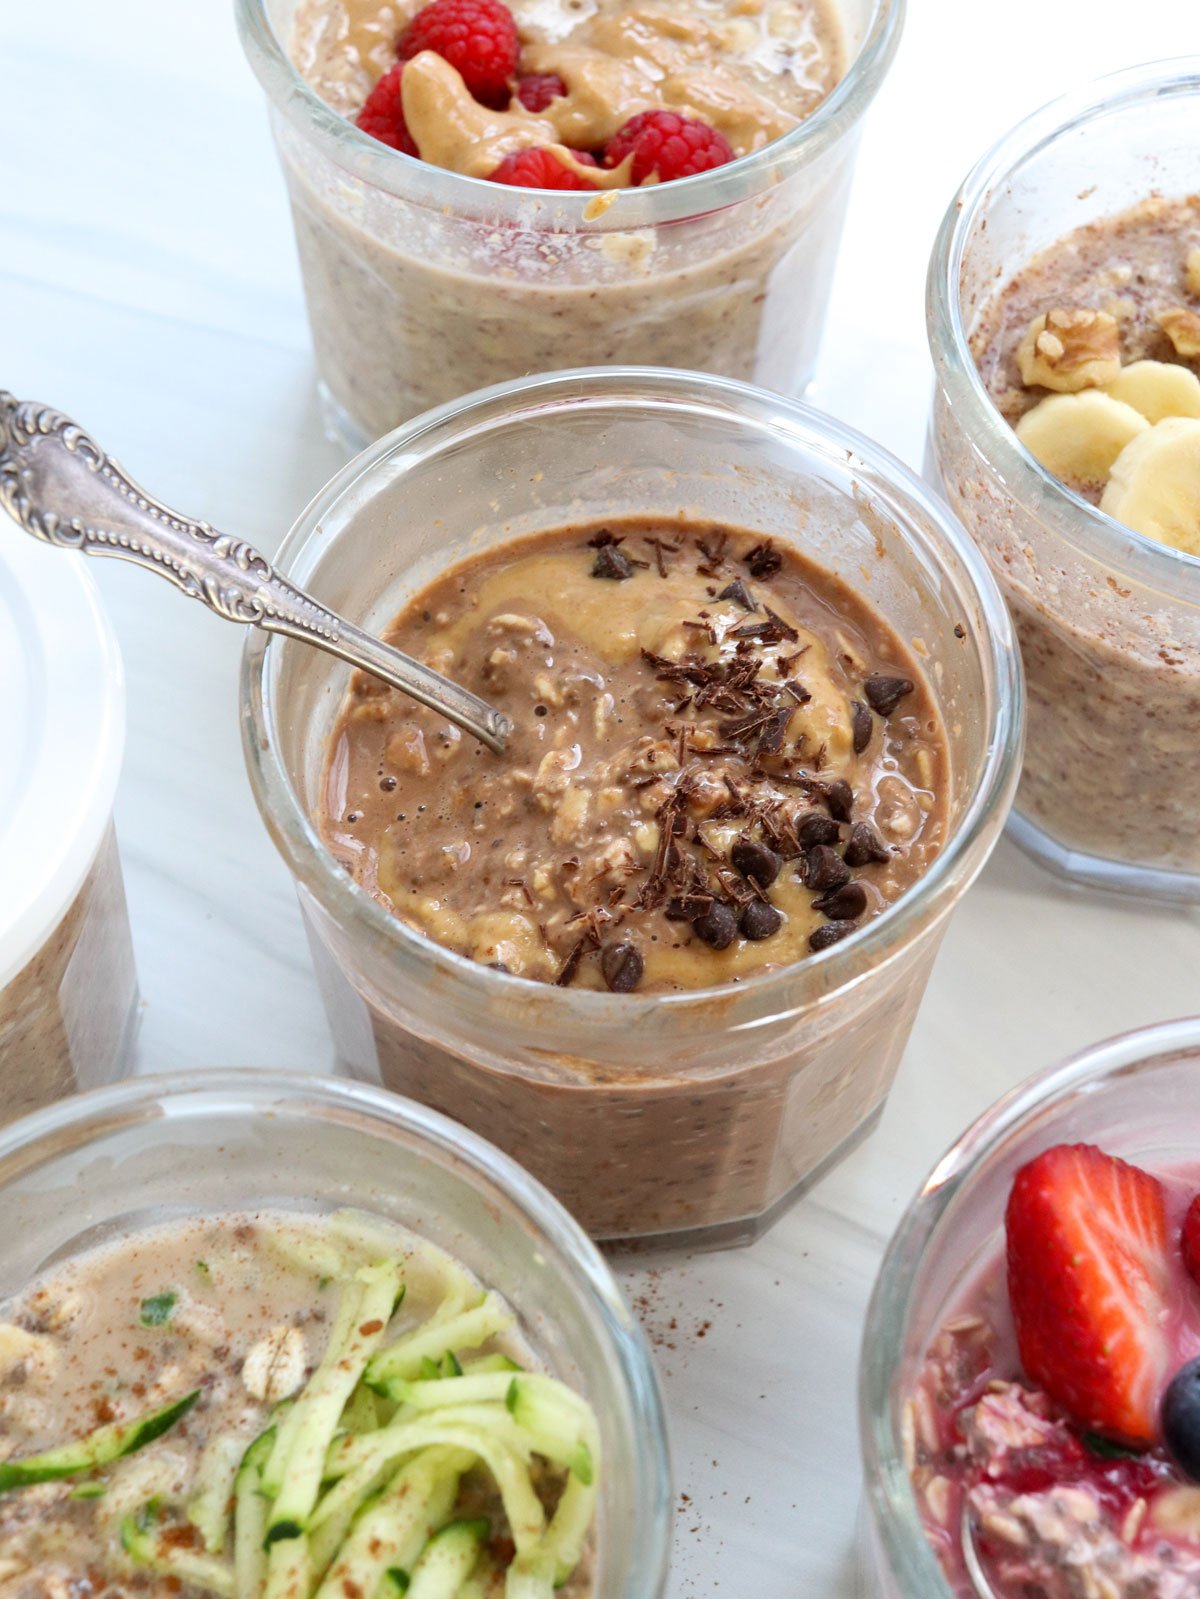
[{"xmin": 1005, "ymin": 1143, "xmax": 1168, "ymax": 1444}]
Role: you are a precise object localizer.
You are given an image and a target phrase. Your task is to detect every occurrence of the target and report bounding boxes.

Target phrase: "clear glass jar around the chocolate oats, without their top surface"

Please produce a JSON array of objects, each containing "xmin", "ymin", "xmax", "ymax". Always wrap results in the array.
[{"xmin": 243, "ymin": 368, "xmax": 1021, "ymax": 1242}]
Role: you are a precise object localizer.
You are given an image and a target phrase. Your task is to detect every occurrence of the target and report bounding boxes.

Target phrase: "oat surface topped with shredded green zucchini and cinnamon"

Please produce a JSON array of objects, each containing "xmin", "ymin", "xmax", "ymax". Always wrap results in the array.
[{"xmin": 0, "ymin": 1212, "xmax": 600, "ymax": 1599}]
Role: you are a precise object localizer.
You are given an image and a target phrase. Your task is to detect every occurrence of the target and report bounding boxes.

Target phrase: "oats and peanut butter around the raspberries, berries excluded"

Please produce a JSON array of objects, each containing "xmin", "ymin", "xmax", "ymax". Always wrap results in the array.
[{"xmin": 291, "ymin": 0, "xmax": 845, "ymax": 181}]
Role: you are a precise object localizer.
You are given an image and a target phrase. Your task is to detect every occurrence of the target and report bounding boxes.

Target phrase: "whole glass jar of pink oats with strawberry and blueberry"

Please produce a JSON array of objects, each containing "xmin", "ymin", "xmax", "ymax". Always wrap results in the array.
[{"xmin": 861, "ymin": 1019, "xmax": 1200, "ymax": 1599}]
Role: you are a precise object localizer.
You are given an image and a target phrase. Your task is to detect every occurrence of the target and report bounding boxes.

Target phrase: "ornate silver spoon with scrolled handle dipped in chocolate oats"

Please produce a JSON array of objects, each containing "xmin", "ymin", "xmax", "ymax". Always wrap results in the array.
[{"xmin": 0, "ymin": 390, "xmax": 512, "ymax": 755}]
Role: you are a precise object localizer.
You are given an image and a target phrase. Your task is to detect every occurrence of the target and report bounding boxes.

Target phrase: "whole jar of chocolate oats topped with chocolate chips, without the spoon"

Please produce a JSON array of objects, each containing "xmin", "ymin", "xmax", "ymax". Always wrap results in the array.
[{"xmin": 245, "ymin": 369, "xmax": 1021, "ymax": 1242}]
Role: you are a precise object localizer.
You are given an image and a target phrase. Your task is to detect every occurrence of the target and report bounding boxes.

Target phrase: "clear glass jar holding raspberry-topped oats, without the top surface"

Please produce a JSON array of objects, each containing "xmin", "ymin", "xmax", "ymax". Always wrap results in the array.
[{"xmin": 237, "ymin": 0, "xmax": 904, "ymax": 449}]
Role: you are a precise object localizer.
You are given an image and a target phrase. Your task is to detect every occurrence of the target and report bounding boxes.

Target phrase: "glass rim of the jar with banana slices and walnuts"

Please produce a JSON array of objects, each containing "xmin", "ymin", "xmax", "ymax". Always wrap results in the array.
[{"xmin": 925, "ymin": 56, "xmax": 1200, "ymax": 604}]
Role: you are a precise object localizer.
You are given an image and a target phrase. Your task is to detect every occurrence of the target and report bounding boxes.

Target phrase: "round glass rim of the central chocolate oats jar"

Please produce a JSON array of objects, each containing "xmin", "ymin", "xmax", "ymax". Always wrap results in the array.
[{"xmin": 240, "ymin": 366, "xmax": 1024, "ymax": 1030}]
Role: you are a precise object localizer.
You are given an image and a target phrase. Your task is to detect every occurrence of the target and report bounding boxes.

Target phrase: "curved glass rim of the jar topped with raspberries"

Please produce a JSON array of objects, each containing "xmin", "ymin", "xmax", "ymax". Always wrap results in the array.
[{"xmin": 235, "ymin": 0, "xmax": 907, "ymax": 232}]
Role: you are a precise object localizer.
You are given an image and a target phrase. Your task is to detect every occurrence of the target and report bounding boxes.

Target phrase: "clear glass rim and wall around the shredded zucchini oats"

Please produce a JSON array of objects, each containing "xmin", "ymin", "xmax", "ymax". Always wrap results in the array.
[{"xmin": 0, "ymin": 1070, "xmax": 672, "ymax": 1599}]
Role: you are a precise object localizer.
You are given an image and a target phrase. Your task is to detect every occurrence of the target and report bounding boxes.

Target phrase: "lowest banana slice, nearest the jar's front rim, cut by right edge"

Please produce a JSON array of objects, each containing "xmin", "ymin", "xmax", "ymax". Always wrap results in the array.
[{"xmin": 1107, "ymin": 413, "xmax": 1200, "ymax": 555}]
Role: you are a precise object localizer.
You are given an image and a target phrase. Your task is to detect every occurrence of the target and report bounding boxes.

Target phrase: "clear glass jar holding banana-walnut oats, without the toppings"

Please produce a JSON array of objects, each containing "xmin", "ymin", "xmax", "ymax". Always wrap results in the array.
[{"xmin": 928, "ymin": 61, "xmax": 1200, "ymax": 902}]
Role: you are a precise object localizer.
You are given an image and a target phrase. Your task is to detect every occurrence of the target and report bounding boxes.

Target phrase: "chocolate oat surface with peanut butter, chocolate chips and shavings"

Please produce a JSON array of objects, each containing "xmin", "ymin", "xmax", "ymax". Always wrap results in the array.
[{"xmin": 322, "ymin": 521, "xmax": 947, "ymax": 993}]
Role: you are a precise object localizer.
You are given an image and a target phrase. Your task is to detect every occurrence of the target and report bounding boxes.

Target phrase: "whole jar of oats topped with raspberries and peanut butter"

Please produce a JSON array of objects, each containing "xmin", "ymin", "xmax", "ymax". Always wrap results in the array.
[{"xmin": 238, "ymin": 0, "xmax": 902, "ymax": 448}]
